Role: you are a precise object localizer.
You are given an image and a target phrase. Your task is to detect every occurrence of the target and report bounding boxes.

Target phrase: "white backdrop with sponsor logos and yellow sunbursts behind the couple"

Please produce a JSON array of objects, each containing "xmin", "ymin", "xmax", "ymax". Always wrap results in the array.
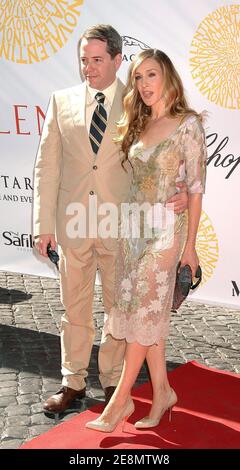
[{"xmin": 0, "ymin": 0, "xmax": 240, "ymax": 308}]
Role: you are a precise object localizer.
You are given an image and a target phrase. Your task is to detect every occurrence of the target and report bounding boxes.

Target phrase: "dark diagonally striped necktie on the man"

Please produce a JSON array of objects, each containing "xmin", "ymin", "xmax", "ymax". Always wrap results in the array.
[{"xmin": 89, "ymin": 93, "xmax": 107, "ymax": 154}]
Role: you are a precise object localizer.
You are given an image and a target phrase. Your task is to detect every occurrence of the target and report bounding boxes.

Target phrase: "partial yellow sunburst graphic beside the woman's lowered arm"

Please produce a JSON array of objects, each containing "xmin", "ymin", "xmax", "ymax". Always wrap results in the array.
[{"xmin": 196, "ymin": 211, "xmax": 219, "ymax": 283}]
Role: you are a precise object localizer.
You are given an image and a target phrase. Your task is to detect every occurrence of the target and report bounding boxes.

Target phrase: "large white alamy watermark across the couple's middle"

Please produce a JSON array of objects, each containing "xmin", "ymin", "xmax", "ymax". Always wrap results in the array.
[{"xmin": 66, "ymin": 195, "xmax": 175, "ymax": 244}]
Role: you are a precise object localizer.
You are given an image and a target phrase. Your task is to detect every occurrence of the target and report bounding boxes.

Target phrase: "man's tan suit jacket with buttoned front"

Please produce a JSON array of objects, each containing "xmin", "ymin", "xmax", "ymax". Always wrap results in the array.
[{"xmin": 34, "ymin": 79, "xmax": 131, "ymax": 248}]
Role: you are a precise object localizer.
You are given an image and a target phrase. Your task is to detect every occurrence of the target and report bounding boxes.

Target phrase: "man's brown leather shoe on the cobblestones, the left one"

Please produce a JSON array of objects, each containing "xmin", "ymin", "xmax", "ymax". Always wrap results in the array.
[{"xmin": 43, "ymin": 387, "xmax": 86, "ymax": 413}]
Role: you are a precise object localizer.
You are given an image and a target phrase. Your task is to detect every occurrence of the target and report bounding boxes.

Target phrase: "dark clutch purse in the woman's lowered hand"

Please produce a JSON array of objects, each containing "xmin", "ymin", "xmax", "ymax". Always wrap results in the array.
[{"xmin": 172, "ymin": 263, "xmax": 202, "ymax": 310}]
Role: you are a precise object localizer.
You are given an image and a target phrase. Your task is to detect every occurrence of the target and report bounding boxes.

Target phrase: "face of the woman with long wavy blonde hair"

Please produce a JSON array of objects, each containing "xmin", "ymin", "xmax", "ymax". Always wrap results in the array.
[{"xmin": 135, "ymin": 58, "xmax": 164, "ymax": 106}]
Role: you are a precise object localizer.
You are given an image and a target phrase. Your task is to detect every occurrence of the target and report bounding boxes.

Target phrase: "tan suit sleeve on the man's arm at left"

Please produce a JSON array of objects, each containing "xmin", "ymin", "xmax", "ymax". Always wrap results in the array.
[{"xmin": 33, "ymin": 94, "xmax": 62, "ymax": 236}]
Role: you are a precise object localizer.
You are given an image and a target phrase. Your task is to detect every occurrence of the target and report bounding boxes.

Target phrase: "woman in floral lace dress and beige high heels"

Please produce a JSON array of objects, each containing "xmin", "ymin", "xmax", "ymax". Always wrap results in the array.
[{"xmin": 87, "ymin": 49, "xmax": 206, "ymax": 432}]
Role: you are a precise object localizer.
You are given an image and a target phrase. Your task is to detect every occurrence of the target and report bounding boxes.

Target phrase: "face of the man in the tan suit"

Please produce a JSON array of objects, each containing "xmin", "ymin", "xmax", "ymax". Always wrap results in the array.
[{"xmin": 80, "ymin": 38, "xmax": 122, "ymax": 91}]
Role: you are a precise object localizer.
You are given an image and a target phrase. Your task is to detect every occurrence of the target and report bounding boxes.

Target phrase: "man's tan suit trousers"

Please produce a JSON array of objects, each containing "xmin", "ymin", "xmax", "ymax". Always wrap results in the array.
[{"xmin": 60, "ymin": 239, "xmax": 126, "ymax": 390}]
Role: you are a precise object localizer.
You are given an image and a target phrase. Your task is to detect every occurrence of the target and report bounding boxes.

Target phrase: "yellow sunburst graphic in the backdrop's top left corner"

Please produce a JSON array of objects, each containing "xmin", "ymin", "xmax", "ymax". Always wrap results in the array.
[{"xmin": 0, "ymin": 0, "xmax": 84, "ymax": 64}]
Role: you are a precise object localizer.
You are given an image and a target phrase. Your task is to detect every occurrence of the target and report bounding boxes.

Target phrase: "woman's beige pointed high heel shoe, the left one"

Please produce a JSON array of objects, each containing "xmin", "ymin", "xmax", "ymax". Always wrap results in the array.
[{"xmin": 85, "ymin": 399, "xmax": 135, "ymax": 432}]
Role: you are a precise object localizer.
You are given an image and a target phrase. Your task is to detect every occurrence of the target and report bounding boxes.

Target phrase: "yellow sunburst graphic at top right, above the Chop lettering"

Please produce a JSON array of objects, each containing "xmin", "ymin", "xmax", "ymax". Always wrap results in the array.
[{"xmin": 190, "ymin": 5, "xmax": 240, "ymax": 109}]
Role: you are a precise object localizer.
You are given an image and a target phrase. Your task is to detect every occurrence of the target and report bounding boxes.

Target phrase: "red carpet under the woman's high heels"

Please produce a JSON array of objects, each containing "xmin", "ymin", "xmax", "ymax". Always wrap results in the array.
[{"xmin": 21, "ymin": 361, "xmax": 240, "ymax": 449}]
